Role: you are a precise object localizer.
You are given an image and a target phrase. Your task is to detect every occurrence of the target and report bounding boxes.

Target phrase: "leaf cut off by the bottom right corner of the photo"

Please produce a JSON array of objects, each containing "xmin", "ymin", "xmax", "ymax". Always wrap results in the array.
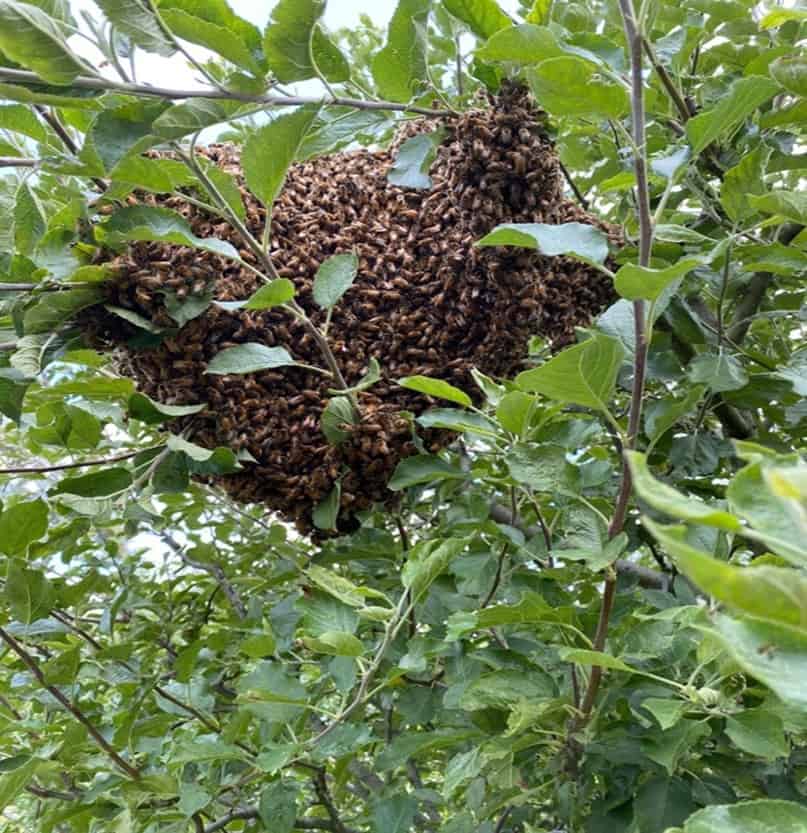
[{"xmin": 669, "ymin": 799, "xmax": 807, "ymax": 833}]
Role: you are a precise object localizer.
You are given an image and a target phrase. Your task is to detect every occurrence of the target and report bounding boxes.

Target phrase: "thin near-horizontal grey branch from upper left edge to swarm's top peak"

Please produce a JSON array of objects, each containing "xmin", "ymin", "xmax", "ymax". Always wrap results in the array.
[{"xmin": 0, "ymin": 67, "xmax": 454, "ymax": 118}]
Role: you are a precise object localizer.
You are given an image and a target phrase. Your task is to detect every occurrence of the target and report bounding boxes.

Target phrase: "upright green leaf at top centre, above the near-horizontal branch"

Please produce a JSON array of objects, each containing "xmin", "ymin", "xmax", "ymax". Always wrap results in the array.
[{"xmin": 371, "ymin": 0, "xmax": 431, "ymax": 101}]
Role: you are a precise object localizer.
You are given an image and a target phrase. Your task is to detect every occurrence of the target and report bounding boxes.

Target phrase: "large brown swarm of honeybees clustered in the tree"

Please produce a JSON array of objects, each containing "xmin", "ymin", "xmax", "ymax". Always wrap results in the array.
[{"xmin": 85, "ymin": 87, "xmax": 619, "ymax": 531}]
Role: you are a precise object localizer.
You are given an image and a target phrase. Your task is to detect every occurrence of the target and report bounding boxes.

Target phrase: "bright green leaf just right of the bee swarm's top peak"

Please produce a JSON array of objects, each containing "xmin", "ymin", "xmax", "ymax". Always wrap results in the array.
[{"xmin": 529, "ymin": 55, "xmax": 632, "ymax": 118}]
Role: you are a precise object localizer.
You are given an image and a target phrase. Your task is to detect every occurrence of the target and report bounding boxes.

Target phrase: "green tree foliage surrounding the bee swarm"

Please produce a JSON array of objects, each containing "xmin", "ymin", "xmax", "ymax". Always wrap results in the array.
[{"xmin": 0, "ymin": 0, "xmax": 807, "ymax": 833}]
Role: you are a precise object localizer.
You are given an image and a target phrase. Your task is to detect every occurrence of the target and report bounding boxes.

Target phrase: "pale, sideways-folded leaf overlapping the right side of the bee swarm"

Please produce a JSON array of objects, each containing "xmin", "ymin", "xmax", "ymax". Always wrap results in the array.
[{"xmin": 476, "ymin": 223, "xmax": 608, "ymax": 263}]
